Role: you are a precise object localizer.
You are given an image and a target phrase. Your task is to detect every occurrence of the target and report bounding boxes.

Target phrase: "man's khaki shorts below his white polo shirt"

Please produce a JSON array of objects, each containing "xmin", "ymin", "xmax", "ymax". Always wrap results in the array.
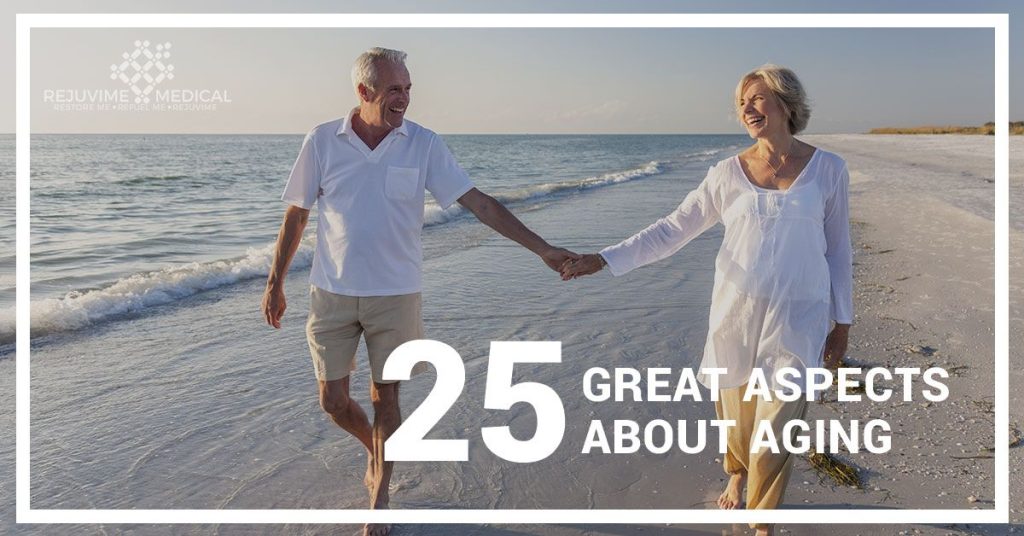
[{"xmin": 306, "ymin": 286, "xmax": 427, "ymax": 383}]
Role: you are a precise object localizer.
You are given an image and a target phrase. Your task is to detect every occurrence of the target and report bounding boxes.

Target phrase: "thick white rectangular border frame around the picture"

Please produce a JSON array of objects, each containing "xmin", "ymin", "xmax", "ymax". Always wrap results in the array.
[{"xmin": 15, "ymin": 13, "xmax": 1010, "ymax": 524}]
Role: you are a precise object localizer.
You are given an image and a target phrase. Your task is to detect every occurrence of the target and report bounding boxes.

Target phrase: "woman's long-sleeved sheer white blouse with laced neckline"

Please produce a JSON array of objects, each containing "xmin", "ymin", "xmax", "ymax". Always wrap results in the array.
[{"xmin": 601, "ymin": 149, "xmax": 853, "ymax": 388}]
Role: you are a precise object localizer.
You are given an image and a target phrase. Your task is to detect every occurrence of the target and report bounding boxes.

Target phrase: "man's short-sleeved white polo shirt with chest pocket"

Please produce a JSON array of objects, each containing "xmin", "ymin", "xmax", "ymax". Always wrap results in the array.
[{"xmin": 281, "ymin": 110, "xmax": 473, "ymax": 296}]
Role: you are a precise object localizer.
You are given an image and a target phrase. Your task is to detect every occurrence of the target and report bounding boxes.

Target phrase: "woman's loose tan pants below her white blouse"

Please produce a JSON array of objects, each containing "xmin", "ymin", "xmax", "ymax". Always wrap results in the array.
[{"xmin": 715, "ymin": 384, "xmax": 807, "ymax": 529}]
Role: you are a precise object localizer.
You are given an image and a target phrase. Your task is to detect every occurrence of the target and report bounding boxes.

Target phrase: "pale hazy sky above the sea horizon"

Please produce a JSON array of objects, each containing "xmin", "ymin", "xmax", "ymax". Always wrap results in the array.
[{"xmin": 8, "ymin": 0, "xmax": 1024, "ymax": 133}]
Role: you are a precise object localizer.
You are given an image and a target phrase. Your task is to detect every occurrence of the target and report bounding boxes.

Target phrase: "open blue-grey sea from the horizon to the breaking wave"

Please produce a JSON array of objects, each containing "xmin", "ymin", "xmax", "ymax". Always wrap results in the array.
[{"xmin": 0, "ymin": 134, "xmax": 745, "ymax": 356}]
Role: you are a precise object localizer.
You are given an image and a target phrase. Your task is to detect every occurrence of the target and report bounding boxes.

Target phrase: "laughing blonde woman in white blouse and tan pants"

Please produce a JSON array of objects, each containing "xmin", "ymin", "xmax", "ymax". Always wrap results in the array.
[{"xmin": 561, "ymin": 65, "xmax": 853, "ymax": 535}]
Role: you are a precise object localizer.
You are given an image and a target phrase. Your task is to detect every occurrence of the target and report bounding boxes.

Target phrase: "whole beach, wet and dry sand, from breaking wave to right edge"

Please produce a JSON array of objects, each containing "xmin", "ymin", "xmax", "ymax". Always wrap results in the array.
[{"xmin": 0, "ymin": 134, "xmax": 1024, "ymax": 536}]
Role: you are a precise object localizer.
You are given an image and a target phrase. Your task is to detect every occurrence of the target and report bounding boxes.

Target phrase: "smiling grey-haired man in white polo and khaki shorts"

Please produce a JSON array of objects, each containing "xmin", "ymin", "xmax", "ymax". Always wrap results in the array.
[{"xmin": 263, "ymin": 48, "xmax": 579, "ymax": 535}]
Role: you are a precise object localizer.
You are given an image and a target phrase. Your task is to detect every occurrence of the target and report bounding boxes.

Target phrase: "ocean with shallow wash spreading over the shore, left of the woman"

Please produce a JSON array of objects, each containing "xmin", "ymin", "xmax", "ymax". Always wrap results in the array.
[{"xmin": 6, "ymin": 130, "xmax": 750, "ymax": 534}]
